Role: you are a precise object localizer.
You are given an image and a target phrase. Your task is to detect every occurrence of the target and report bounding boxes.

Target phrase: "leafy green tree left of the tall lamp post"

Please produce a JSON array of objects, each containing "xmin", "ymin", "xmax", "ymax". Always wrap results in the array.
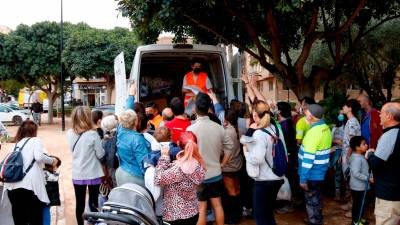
[{"xmin": 0, "ymin": 22, "xmax": 60, "ymax": 123}]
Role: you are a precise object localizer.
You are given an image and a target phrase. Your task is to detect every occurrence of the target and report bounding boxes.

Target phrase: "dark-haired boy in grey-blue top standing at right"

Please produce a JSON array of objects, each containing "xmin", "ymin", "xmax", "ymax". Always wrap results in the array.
[{"xmin": 350, "ymin": 136, "xmax": 373, "ymax": 225}]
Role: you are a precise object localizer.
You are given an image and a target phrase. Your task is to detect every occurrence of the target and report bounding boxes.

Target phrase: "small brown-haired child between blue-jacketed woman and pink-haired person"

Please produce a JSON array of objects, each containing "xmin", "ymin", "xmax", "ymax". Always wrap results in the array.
[{"xmin": 143, "ymin": 127, "xmax": 181, "ymax": 218}]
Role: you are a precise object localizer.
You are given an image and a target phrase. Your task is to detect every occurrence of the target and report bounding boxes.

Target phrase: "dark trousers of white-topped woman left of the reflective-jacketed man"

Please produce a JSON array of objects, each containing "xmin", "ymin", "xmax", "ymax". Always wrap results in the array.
[{"xmin": 253, "ymin": 180, "xmax": 283, "ymax": 225}]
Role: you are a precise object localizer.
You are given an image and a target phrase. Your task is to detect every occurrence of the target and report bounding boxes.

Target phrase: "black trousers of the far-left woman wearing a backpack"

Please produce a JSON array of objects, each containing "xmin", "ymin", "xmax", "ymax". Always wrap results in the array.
[{"xmin": 7, "ymin": 188, "xmax": 45, "ymax": 225}]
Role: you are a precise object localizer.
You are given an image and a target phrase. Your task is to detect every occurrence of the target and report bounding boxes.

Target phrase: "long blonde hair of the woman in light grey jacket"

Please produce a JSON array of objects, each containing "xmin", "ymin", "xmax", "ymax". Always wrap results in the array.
[{"xmin": 71, "ymin": 106, "xmax": 94, "ymax": 134}]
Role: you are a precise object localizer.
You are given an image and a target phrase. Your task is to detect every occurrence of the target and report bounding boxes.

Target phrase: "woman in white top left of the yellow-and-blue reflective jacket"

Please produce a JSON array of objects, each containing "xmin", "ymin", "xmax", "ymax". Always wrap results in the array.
[{"xmin": 241, "ymin": 101, "xmax": 284, "ymax": 225}]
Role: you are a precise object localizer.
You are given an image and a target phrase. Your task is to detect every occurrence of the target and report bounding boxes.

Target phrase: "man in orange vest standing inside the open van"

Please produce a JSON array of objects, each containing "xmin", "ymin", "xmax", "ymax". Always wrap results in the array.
[{"xmin": 182, "ymin": 58, "xmax": 212, "ymax": 108}]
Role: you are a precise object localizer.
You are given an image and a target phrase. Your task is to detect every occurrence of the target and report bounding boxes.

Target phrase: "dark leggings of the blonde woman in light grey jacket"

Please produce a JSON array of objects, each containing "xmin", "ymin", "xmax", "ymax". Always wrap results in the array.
[{"xmin": 74, "ymin": 184, "xmax": 100, "ymax": 225}]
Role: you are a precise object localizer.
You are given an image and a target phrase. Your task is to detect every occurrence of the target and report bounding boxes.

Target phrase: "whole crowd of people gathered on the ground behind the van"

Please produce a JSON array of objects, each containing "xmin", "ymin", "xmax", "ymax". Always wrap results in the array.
[{"xmin": 4, "ymin": 71, "xmax": 400, "ymax": 225}]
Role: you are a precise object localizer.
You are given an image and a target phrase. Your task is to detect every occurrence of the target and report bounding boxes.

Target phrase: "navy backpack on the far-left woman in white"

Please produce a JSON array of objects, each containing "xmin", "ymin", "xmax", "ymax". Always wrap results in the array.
[{"xmin": 0, "ymin": 138, "xmax": 35, "ymax": 183}]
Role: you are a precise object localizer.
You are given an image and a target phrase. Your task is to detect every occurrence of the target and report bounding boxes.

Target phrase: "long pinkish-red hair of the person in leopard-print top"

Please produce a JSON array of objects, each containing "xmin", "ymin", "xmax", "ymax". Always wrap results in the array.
[{"xmin": 176, "ymin": 131, "xmax": 206, "ymax": 173}]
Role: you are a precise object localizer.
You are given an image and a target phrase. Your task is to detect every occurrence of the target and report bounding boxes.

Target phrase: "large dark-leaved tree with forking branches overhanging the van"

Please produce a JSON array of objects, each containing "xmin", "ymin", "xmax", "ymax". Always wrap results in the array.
[{"xmin": 119, "ymin": 0, "xmax": 400, "ymax": 98}]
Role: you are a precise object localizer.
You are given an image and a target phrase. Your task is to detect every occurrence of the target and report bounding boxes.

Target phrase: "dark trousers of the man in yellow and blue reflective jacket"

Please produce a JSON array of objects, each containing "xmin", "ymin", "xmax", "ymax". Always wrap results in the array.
[{"xmin": 304, "ymin": 181, "xmax": 323, "ymax": 225}]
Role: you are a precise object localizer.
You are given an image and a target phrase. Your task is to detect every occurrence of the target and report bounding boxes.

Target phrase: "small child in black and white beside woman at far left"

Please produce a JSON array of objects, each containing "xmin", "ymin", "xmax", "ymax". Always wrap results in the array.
[{"xmin": 43, "ymin": 156, "xmax": 61, "ymax": 225}]
